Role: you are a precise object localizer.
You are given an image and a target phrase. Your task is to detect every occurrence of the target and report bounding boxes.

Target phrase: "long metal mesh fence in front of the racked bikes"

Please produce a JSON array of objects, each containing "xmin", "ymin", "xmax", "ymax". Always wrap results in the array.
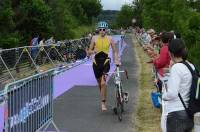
[{"xmin": 0, "ymin": 38, "xmax": 90, "ymax": 90}]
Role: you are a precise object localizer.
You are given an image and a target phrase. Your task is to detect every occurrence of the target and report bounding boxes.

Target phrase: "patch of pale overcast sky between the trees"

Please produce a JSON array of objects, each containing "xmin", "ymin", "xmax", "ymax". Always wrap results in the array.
[{"xmin": 101, "ymin": 0, "xmax": 133, "ymax": 10}]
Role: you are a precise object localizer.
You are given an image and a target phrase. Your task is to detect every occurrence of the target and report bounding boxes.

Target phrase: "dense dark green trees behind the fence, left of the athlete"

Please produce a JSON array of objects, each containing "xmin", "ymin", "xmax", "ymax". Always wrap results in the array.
[{"xmin": 0, "ymin": 0, "xmax": 101, "ymax": 48}]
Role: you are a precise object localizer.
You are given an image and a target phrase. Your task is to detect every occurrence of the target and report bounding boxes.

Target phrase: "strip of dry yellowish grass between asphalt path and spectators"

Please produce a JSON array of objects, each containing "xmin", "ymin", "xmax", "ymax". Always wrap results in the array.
[{"xmin": 133, "ymin": 36, "xmax": 161, "ymax": 132}]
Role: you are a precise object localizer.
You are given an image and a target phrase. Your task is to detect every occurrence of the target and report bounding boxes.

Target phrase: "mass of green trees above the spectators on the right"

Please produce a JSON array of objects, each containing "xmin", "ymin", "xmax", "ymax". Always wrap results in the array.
[{"xmin": 135, "ymin": 0, "xmax": 200, "ymax": 67}]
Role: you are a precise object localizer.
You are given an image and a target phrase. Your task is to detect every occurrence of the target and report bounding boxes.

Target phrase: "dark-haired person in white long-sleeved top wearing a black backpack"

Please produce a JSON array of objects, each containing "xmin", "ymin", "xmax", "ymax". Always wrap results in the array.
[{"xmin": 163, "ymin": 39, "xmax": 194, "ymax": 132}]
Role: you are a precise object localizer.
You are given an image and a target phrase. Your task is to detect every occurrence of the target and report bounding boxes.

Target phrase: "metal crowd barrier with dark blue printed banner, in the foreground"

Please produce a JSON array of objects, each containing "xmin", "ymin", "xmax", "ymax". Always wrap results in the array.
[{"xmin": 3, "ymin": 70, "xmax": 59, "ymax": 132}]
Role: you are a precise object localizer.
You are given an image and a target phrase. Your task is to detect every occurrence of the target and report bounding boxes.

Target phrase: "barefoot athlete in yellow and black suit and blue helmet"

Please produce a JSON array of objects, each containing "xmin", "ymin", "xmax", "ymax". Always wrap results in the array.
[{"xmin": 88, "ymin": 21, "xmax": 120, "ymax": 111}]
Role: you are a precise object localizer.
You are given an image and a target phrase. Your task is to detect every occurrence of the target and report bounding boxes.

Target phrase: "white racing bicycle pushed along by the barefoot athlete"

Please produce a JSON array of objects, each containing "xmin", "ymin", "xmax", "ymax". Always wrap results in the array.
[{"xmin": 108, "ymin": 65, "xmax": 128, "ymax": 122}]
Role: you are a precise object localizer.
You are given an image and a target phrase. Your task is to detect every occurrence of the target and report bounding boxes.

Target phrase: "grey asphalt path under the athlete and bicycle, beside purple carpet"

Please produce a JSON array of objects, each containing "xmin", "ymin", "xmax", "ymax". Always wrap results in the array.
[{"xmin": 49, "ymin": 36, "xmax": 138, "ymax": 132}]
